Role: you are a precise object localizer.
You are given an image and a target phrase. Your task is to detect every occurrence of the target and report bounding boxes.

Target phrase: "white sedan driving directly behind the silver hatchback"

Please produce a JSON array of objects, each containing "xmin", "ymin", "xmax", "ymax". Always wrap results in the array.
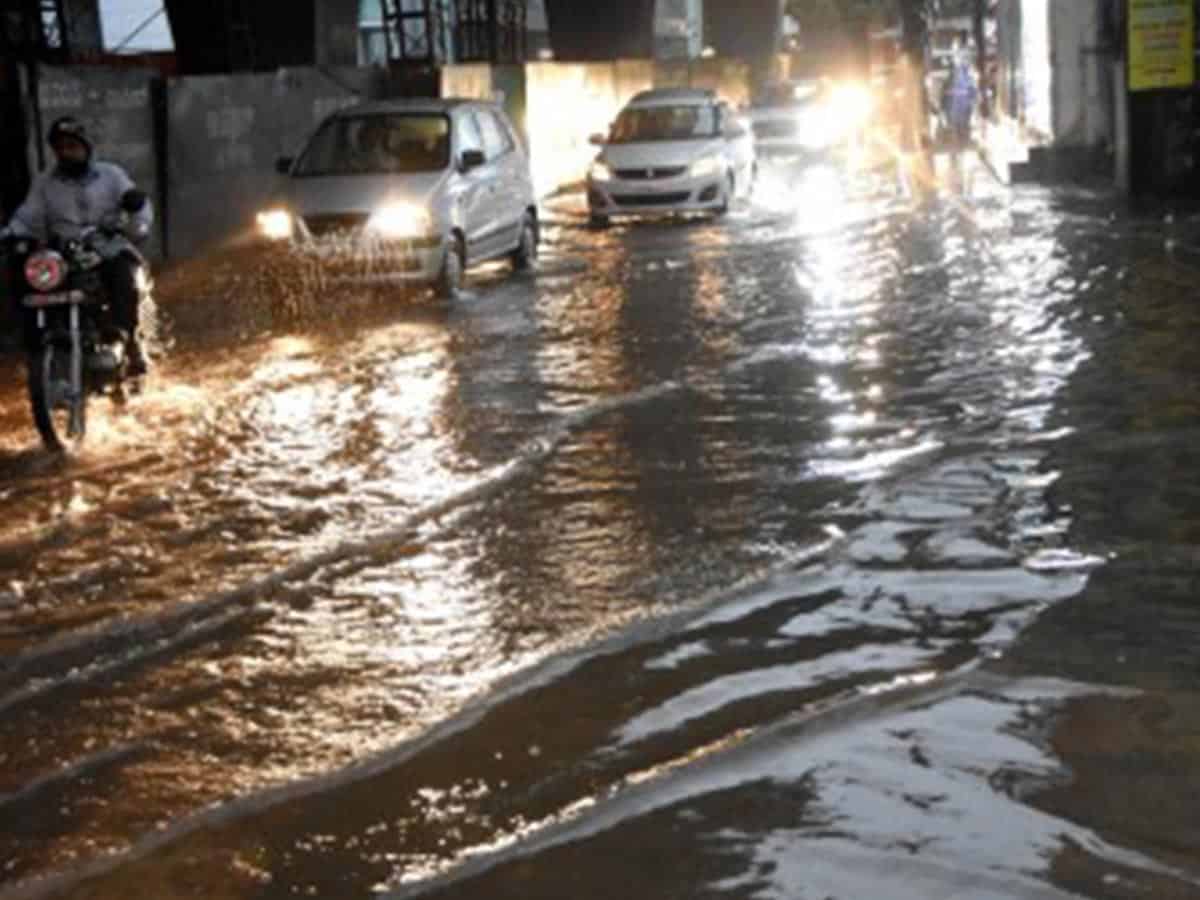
[{"xmin": 588, "ymin": 89, "xmax": 757, "ymax": 226}]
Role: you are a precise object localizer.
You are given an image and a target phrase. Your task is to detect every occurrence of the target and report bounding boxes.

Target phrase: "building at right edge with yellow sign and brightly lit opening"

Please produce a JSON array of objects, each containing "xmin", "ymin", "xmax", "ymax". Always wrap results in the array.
[{"xmin": 992, "ymin": 0, "xmax": 1200, "ymax": 198}]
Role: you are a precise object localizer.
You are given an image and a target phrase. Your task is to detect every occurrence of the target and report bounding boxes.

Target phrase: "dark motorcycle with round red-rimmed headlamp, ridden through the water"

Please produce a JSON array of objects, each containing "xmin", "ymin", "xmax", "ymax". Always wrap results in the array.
[{"xmin": 12, "ymin": 191, "xmax": 149, "ymax": 451}]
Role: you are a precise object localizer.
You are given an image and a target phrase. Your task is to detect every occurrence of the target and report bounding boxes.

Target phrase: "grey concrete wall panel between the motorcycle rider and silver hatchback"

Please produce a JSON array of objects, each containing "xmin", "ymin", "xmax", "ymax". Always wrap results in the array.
[{"xmin": 167, "ymin": 68, "xmax": 378, "ymax": 258}]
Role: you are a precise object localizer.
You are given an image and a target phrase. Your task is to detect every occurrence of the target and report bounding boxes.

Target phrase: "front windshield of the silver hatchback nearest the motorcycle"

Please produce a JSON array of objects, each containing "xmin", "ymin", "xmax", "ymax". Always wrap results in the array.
[{"xmin": 295, "ymin": 113, "xmax": 450, "ymax": 176}]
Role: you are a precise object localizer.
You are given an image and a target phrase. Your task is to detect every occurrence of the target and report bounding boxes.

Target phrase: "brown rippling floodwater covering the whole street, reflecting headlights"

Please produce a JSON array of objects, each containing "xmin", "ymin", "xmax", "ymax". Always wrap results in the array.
[{"xmin": 0, "ymin": 162, "xmax": 1200, "ymax": 900}]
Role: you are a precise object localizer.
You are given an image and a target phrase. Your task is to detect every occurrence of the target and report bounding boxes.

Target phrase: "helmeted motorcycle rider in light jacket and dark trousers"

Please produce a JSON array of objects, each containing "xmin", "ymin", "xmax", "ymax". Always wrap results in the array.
[{"xmin": 0, "ymin": 115, "xmax": 154, "ymax": 376}]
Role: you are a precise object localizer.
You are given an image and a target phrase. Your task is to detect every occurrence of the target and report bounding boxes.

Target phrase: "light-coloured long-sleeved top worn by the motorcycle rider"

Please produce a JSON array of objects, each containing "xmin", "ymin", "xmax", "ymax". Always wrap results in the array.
[{"xmin": 7, "ymin": 161, "xmax": 154, "ymax": 240}]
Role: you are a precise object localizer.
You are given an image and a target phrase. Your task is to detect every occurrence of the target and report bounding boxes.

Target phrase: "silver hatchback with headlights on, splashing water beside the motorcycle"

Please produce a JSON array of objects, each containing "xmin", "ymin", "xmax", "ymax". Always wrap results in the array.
[{"xmin": 258, "ymin": 100, "xmax": 539, "ymax": 296}]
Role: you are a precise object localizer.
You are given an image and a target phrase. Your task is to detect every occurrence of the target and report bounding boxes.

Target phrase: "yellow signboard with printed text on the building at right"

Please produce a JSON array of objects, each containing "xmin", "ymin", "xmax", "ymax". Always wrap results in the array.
[{"xmin": 1129, "ymin": 0, "xmax": 1195, "ymax": 91}]
